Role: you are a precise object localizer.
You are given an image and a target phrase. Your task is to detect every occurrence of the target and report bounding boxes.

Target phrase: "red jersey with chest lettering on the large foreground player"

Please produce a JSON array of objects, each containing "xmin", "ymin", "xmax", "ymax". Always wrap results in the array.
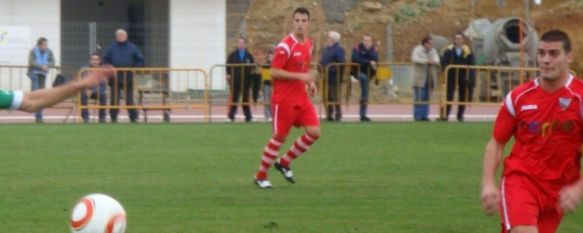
[{"xmin": 493, "ymin": 75, "xmax": 583, "ymax": 197}]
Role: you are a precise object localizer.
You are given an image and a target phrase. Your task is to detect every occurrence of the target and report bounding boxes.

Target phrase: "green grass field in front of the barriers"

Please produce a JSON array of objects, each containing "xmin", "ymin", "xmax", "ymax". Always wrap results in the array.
[{"xmin": 0, "ymin": 123, "xmax": 583, "ymax": 233}]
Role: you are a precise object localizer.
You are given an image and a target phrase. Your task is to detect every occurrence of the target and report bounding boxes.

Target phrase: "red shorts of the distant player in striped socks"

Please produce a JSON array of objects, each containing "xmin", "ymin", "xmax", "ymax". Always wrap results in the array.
[{"xmin": 272, "ymin": 102, "xmax": 320, "ymax": 137}]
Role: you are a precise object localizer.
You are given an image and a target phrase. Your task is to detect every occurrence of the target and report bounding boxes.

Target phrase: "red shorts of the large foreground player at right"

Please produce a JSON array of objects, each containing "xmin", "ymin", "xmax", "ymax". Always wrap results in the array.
[{"xmin": 500, "ymin": 174, "xmax": 563, "ymax": 233}]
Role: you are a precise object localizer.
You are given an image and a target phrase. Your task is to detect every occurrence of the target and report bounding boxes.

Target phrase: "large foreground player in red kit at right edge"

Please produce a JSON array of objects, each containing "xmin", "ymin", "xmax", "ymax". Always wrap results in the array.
[{"xmin": 481, "ymin": 30, "xmax": 583, "ymax": 233}]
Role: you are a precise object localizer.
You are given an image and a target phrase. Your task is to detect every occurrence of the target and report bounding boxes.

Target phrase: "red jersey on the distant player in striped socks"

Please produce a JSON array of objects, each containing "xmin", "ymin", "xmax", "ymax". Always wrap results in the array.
[{"xmin": 271, "ymin": 34, "xmax": 312, "ymax": 104}]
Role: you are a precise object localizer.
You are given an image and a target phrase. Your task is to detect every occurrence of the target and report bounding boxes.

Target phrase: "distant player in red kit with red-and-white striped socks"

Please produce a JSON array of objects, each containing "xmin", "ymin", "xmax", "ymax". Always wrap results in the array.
[{"xmin": 254, "ymin": 7, "xmax": 320, "ymax": 188}]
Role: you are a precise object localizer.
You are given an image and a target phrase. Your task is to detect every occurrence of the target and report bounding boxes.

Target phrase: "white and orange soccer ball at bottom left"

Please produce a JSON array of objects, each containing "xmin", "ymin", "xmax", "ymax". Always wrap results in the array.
[{"xmin": 71, "ymin": 193, "xmax": 126, "ymax": 233}]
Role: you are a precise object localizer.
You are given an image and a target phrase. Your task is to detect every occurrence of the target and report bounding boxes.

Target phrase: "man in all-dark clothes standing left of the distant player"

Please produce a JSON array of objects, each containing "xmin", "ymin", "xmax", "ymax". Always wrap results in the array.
[{"xmin": 227, "ymin": 37, "xmax": 255, "ymax": 122}]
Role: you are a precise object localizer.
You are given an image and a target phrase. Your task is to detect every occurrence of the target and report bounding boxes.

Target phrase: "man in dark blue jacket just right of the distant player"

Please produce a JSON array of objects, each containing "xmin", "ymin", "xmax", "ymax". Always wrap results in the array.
[{"xmin": 320, "ymin": 31, "xmax": 345, "ymax": 121}]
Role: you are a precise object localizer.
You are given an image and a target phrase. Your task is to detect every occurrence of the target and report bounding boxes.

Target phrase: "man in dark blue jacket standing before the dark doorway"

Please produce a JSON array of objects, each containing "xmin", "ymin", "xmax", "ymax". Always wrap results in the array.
[{"xmin": 103, "ymin": 29, "xmax": 144, "ymax": 123}]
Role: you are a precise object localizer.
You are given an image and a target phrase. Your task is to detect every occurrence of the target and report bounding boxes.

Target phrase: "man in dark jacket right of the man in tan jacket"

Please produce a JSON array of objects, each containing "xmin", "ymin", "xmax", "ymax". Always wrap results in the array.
[{"xmin": 440, "ymin": 33, "xmax": 476, "ymax": 121}]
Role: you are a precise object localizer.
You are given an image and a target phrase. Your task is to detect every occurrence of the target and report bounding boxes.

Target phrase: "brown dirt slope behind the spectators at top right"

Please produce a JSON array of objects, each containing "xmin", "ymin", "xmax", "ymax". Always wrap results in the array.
[{"xmin": 240, "ymin": 0, "xmax": 583, "ymax": 74}]
